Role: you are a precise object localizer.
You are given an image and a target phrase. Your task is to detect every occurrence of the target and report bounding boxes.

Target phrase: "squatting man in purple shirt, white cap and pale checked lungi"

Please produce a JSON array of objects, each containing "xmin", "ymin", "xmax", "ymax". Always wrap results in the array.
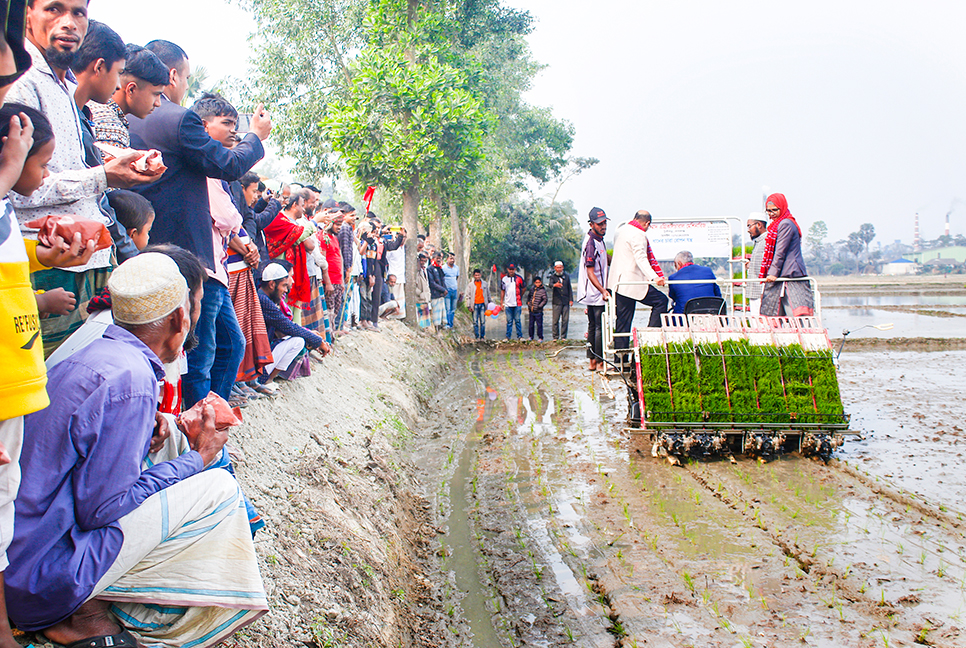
[{"xmin": 6, "ymin": 253, "xmax": 268, "ymax": 646}]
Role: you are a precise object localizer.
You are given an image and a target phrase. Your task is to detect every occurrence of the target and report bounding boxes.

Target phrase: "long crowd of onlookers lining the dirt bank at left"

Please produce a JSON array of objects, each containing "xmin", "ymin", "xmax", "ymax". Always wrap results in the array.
[{"xmin": 0, "ymin": 0, "xmax": 432, "ymax": 648}]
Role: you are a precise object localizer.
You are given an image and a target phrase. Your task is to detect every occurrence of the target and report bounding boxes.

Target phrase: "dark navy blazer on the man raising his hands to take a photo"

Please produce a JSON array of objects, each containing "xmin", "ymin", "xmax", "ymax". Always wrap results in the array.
[{"xmin": 129, "ymin": 97, "xmax": 265, "ymax": 270}]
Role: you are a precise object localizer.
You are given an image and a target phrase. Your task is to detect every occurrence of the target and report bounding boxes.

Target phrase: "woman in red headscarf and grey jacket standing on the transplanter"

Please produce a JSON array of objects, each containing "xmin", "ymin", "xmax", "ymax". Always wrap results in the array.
[{"xmin": 758, "ymin": 194, "xmax": 814, "ymax": 317}]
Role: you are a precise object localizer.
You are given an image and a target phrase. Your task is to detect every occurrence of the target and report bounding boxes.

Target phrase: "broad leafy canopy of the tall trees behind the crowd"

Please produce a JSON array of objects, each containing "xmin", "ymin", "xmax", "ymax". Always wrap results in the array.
[{"xmin": 241, "ymin": 0, "xmax": 596, "ymax": 302}]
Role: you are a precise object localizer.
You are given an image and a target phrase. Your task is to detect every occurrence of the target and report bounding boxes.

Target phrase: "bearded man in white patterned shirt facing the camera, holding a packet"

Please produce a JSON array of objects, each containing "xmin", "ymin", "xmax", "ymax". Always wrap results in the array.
[{"xmin": 6, "ymin": 0, "xmax": 156, "ymax": 355}]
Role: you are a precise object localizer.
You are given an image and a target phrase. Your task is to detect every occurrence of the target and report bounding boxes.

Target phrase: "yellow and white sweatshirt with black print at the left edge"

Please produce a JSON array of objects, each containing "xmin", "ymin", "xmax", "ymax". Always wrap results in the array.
[{"xmin": 0, "ymin": 199, "xmax": 50, "ymax": 420}]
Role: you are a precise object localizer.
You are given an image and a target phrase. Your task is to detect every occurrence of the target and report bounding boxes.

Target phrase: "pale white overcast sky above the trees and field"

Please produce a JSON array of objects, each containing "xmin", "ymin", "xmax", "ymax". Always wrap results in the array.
[{"xmin": 90, "ymin": 0, "xmax": 966, "ymax": 244}]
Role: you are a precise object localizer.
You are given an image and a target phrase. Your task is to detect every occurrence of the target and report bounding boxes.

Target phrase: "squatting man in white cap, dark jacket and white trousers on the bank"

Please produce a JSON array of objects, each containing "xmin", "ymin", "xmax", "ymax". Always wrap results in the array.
[{"xmin": 258, "ymin": 263, "xmax": 329, "ymax": 394}]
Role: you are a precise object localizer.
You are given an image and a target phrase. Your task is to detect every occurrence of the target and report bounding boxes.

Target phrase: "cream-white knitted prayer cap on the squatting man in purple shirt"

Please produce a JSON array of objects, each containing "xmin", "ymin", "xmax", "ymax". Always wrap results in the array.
[{"xmin": 107, "ymin": 252, "xmax": 188, "ymax": 324}]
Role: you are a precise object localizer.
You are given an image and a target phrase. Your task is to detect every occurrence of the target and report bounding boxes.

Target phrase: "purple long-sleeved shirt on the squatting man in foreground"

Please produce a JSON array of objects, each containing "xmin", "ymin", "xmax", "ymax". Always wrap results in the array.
[{"xmin": 5, "ymin": 325, "xmax": 203, "ymax": 631}]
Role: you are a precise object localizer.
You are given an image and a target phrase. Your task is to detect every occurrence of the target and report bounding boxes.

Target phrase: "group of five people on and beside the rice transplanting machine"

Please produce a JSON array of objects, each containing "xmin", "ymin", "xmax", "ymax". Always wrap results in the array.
[{"xmin": 580, "ymin": 193, "xmax": 813, "ymax": 371}]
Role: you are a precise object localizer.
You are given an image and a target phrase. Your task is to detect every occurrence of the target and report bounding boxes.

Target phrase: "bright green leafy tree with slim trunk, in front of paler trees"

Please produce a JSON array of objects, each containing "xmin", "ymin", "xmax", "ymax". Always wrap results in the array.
[{"xmin": 323, "ymin": 0, "xmax": 490, "ymax": 321}]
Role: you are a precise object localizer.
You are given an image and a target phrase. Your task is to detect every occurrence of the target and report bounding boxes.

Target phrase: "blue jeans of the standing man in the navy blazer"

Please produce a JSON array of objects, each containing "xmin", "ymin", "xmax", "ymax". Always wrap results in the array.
[{"xmin": 181, "ymin": 279, "xmax": 245, "ymax": 409}]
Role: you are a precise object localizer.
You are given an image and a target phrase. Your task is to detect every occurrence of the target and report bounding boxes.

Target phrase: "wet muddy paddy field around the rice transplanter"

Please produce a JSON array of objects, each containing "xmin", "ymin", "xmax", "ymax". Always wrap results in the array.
[{"xmin": 414, "ymin": 346, "xmax": 966, "ymax": 648}]
